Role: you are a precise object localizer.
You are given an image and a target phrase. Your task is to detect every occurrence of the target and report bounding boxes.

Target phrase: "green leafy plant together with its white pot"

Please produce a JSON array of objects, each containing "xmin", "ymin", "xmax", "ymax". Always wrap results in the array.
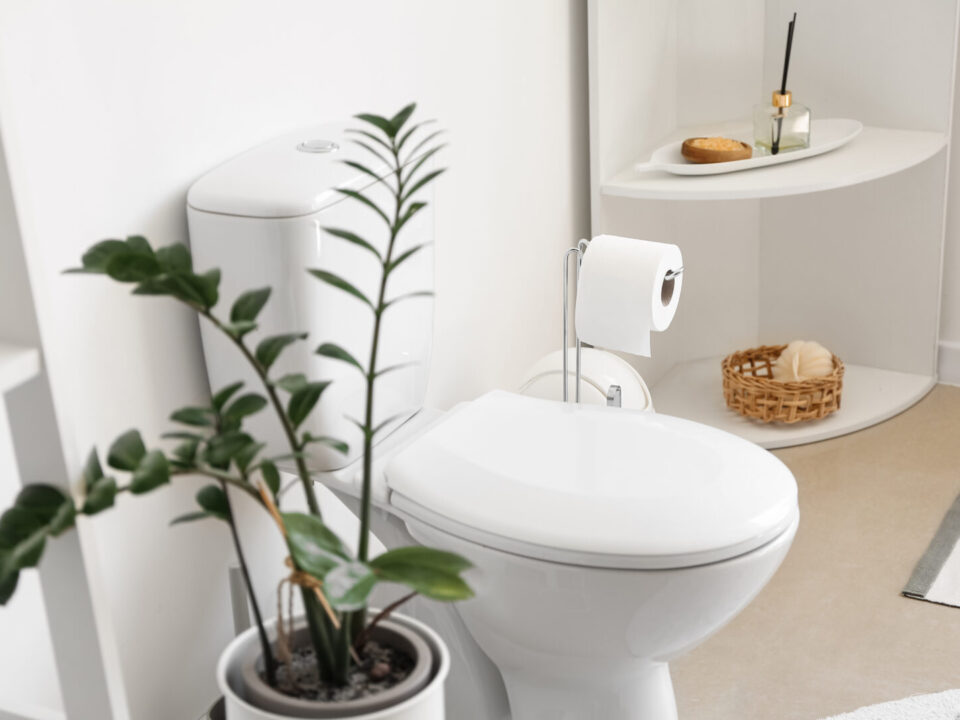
[{"xmin": 0, "ymin": 104, "xmax": 472, "ymax": 720}]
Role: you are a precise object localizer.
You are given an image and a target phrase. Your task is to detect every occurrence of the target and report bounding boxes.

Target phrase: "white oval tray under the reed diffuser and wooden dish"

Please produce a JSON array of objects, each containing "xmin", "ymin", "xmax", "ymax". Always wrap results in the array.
[{"xmin": 635, "ymin": 118, "xmax": 863, "ymax": 175}]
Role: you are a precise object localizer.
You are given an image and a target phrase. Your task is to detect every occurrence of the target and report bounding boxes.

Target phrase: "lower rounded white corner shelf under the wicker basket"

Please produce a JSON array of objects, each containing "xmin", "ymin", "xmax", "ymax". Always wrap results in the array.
[{"xmin": 651, "ymin": 357, "xmax": 936, "ymax": 449}]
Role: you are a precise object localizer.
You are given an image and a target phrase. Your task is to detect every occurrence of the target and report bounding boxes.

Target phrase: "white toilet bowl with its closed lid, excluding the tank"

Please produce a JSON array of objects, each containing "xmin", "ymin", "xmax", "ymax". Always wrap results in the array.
[{"xmin": 325, "ymin": 391, "xmax": 799, "ymax": 720}]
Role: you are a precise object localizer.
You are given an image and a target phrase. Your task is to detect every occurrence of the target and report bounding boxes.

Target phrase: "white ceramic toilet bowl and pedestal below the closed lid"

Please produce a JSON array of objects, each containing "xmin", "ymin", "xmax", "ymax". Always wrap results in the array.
[{"xmin": 407, "ymin": 510, "xmax": 799, "ymax": 720}]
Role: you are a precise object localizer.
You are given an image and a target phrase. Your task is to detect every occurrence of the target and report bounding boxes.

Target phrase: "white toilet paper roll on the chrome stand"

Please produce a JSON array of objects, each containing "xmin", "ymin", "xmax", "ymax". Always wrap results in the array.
[{"xmin": 576, "ymin": 235, "xmax": 683, "ymax": 357}]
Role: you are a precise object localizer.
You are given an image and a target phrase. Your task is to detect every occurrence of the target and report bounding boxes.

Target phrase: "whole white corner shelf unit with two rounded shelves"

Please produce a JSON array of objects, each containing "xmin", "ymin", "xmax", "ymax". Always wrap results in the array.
[{"xmin": 588, "ymin": 0, "xmax": 960, "ymax": 448}]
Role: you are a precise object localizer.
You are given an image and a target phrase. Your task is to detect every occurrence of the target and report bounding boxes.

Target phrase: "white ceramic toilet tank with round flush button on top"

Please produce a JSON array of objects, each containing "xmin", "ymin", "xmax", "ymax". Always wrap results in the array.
[{"xmin": 187, "ymin": 123, "xmax": 434, "ymax": 471}]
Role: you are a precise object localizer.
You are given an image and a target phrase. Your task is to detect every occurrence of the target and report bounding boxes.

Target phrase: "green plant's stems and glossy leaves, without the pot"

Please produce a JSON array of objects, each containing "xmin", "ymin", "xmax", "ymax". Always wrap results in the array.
[{"xmin": 0, "ymin": 105, "xmax": 472, "ymax": 704}]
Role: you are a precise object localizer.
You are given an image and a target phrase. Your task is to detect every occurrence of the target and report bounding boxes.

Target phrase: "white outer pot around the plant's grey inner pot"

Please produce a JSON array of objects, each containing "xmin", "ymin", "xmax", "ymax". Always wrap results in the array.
[{"xmin": 217, "ymin": 614, "xmax": 450, "ymax": 720}]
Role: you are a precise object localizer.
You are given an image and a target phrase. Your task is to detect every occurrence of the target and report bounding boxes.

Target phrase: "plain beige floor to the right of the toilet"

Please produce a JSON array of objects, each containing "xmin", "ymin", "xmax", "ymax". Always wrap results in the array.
[{"xmin": 673, "ymin": 385, "xmax": 960, "ymax": 720}]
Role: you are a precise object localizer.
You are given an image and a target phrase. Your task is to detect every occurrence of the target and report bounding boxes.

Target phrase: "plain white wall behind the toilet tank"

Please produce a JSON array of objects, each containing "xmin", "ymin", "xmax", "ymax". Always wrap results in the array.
[{"xmin": 0, "ymin": 0, "xmax": 588, "ymax": 720}]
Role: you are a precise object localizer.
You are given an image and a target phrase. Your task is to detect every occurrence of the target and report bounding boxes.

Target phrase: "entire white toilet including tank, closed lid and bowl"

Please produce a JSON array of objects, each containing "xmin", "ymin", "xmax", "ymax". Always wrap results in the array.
[{"xmin": 187, "ymin": 124, "xmax": 798, "ymax": 720}]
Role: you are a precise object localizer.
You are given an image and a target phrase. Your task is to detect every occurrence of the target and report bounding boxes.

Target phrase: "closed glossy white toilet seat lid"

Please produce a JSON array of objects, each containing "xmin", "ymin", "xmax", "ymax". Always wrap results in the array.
[{"xmin": 386, "ymin": 391, "xmax": 797, "ymax": 568}]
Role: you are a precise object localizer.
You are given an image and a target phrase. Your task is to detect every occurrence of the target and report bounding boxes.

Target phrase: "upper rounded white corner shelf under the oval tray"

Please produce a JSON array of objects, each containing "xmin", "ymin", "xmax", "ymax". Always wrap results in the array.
[{"xmin": 600, "ymin": 122, "xmax": 947, "ymax": 200}]
